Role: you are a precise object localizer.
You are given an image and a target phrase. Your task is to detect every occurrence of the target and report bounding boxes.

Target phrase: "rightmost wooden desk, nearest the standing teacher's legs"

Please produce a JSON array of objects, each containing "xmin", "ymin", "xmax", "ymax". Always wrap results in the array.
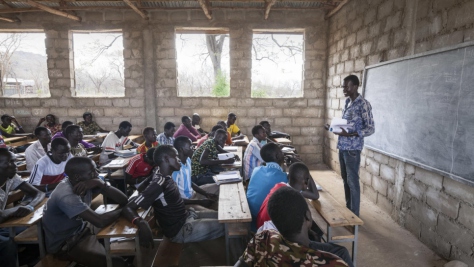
[{"xmin": 308, "ymin": 189, "xmax": 364, "ymax": 266}]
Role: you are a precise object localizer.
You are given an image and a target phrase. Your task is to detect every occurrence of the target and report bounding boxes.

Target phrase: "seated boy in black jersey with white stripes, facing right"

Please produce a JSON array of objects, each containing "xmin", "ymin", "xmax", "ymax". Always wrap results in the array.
[{"xmin": 122, "ymin": 145, "xmax": 225, "ymax": 247}]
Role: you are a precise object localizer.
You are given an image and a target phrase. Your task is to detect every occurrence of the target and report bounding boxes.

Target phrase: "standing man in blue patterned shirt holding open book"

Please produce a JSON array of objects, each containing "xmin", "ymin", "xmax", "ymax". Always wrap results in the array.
[{"xmin": 328, "ymin": 75, "xmax": 375, "ymax": 216}]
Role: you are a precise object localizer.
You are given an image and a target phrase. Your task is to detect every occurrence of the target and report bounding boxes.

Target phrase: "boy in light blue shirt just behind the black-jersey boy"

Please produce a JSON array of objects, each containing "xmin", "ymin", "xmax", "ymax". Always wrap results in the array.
[{"xmin": 171, "ymin": 137, "xmax": 220, "ymax": 207}]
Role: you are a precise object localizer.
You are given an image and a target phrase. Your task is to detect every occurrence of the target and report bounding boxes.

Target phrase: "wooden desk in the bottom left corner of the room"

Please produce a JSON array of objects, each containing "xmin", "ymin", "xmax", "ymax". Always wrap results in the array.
[{"xmin": 0, "ymin": 198, "xmax": 48, "ymax": 266}]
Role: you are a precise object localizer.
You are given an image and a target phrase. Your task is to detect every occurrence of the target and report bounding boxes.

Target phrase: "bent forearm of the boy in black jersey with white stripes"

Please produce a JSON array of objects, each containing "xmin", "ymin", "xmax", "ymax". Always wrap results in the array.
[{"xmin": 122, "ymin": 200, "xmax": 155, "ymax": 248}]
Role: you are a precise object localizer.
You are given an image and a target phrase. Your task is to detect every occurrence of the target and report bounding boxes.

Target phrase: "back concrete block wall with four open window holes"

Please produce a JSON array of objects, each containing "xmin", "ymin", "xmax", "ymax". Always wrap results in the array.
[{"xmin": 0, "ymin": 10, "xmax": 328, "ymax": 166}]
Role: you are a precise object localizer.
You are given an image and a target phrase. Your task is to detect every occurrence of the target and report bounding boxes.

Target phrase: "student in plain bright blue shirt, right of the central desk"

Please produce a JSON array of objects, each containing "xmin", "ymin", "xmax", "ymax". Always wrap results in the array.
[{"xmin": 247, "ymin": 143, "xmax": 288, "ymax": 231}]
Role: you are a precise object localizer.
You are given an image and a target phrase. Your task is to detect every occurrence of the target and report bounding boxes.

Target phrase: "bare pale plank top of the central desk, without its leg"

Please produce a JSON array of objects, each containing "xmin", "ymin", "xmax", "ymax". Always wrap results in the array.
[{"xmin": 218, "ymin": 182, "xmax": 252, "ymax": 223}]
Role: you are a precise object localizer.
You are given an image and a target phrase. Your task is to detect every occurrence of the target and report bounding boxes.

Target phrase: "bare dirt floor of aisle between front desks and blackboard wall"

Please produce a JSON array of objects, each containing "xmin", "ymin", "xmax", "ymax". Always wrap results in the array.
[{"xmin": 311, "ymin": 168, "xmax": 446, "ymax": 267}]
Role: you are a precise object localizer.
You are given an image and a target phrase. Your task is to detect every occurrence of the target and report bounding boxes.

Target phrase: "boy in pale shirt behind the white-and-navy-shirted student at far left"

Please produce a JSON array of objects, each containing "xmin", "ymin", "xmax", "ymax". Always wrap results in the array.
[{"xmin": 25, "ymin": 126, "xmax": 51, "ymax": 171}]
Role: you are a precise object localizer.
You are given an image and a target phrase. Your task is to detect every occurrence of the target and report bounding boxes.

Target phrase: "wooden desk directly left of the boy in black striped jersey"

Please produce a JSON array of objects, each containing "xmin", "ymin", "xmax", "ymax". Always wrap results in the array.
[{"xmin": 96, "ymin": 204, "xmax": 150, "ymax": 267}]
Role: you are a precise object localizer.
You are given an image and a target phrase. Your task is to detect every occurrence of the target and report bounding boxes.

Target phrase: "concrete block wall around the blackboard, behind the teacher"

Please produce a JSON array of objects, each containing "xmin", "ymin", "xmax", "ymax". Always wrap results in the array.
[{"xmin": 324, "ymin": 0, "xmax": 474, "ymax": 266}]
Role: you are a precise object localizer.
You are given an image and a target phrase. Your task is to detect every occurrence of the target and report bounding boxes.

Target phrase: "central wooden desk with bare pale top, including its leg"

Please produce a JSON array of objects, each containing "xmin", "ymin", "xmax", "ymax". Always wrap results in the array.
[{"xmin": 218, "ymin": 182, "xmax": 252, "ymax": 265}]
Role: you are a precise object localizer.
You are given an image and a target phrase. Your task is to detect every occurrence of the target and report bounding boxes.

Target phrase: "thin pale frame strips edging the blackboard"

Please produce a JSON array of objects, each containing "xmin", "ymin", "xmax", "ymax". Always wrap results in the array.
[{"xmin": 361, "ymin": 41, "xmax": 474, "ymax": 187}]
